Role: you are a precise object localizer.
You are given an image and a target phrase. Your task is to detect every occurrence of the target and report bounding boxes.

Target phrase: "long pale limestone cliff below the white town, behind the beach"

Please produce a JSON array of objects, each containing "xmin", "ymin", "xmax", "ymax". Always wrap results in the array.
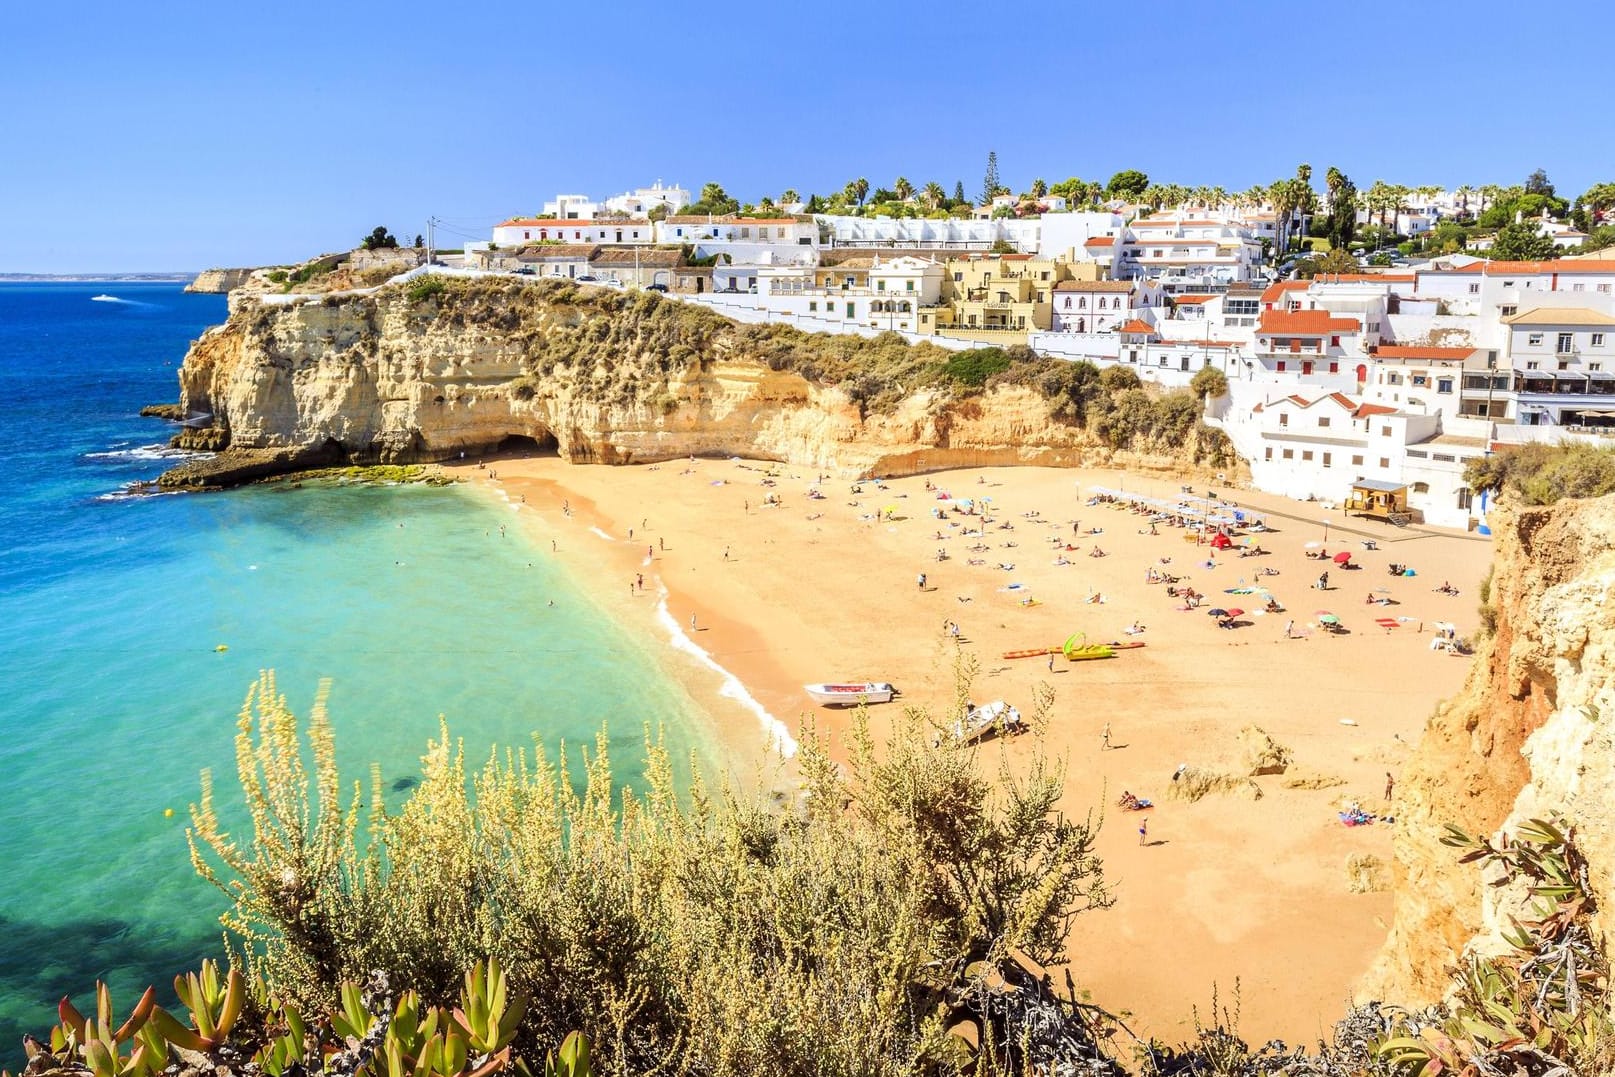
[{"xmin": 160, "ymin": 278, "xmax": 1226, "ymax": 487}]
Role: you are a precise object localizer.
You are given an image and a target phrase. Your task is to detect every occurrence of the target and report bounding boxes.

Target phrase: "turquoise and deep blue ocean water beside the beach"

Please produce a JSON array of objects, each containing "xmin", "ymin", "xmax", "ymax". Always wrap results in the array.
[{"xmin": 0, "ymin": 284, "xmax": 712, "ymax": 1067}]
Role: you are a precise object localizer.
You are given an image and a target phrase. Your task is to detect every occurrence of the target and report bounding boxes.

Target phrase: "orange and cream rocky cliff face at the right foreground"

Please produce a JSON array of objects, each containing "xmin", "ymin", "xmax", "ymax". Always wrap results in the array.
[{"xmin": 1365, "ymin": 496, "xmax": 1615, "ymax": 1003}]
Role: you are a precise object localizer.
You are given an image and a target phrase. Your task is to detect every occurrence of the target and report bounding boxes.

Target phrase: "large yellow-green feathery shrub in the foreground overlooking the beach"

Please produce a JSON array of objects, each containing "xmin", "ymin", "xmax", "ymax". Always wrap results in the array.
[{"xmin": 191, "ymin": 672, "xmax": 1110, "ymax": 1077}]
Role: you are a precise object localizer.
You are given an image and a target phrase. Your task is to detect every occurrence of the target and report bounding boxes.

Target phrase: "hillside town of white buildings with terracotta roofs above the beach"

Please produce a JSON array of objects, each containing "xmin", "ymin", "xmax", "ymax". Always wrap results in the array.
[{"xmin": 426, "ymin": 170, "xmax": 1615, "ymax": 530}]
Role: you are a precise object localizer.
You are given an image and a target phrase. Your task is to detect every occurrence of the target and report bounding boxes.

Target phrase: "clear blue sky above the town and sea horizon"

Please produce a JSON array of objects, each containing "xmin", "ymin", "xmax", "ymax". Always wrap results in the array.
[{"xmin": 0, "ymin": 0, "xmax": 1615, "ymax": 271}]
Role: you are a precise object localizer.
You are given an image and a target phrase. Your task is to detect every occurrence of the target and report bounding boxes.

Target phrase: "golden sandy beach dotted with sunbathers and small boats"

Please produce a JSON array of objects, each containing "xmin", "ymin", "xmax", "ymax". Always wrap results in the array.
[{"xmin": 451, "ymin": 457, "xmax": 1491, "ymax": 1041}]
